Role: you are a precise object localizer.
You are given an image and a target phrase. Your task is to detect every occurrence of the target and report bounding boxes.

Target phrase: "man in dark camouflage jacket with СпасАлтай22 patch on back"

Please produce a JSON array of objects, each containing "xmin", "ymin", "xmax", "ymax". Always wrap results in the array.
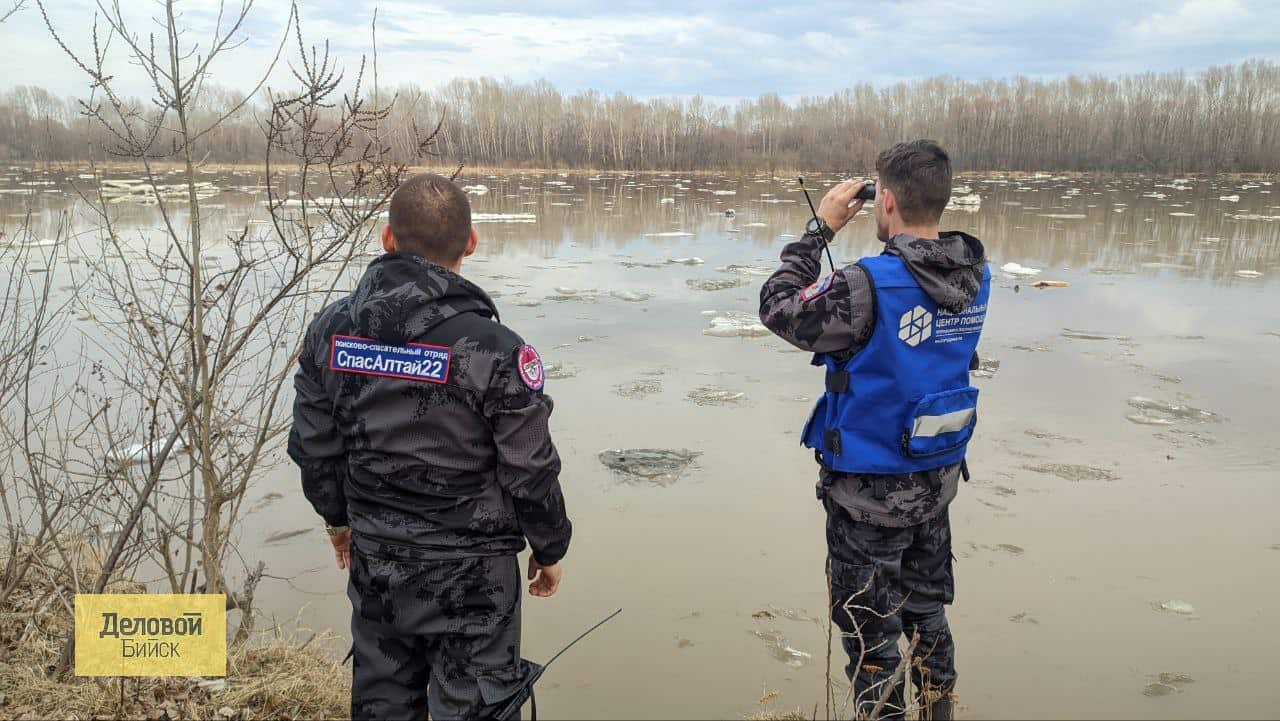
[{"xmin": 289, "ymin": 174, "xmax": 572, "ymax": 720}]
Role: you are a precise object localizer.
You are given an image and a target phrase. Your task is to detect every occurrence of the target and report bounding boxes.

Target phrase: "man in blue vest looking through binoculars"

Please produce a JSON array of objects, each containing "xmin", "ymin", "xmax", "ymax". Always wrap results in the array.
[{"xmin": 760, "ymin": 140, "xmax": 991, "ymax": 718}]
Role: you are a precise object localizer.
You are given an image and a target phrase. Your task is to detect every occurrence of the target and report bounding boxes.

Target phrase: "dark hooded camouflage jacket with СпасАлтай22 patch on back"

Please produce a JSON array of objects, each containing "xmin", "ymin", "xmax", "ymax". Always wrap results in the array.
[{"xmin": 288, "ymin": 254, "xmax": 572, "ymax": 563}]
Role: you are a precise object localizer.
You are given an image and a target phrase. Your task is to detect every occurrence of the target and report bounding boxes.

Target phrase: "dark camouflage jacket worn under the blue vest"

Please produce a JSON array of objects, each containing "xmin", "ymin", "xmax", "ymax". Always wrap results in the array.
[{"xmin": 760, "ymin": 232, "xmax": 986, "ymax": 528}]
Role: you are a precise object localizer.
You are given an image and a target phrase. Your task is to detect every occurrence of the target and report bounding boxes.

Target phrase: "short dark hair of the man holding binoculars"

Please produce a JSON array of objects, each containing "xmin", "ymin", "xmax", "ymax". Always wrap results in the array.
[{"xmin": 876, "ymin": 140, "xmax": 951, "ymax": 223}]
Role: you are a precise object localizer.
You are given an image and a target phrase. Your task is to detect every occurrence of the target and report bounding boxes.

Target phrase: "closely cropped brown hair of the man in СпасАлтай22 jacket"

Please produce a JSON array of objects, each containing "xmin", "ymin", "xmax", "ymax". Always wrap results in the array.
[{"xmin": 389, "ymin": 173, "xmax": 471, "ymax": 265}]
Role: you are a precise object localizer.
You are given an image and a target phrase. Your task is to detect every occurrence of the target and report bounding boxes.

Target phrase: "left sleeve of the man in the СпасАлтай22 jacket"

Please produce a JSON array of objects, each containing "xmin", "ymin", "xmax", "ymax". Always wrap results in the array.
[{"xmin": 289, "ymin": 324, "xmax": 347, "ymax": 526}]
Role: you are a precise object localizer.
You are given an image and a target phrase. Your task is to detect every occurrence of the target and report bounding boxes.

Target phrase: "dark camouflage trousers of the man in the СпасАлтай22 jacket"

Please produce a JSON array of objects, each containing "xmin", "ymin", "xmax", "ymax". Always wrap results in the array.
[{"xmin": 347, "ymin": 543, "xmax": 525, "ymax": 721}]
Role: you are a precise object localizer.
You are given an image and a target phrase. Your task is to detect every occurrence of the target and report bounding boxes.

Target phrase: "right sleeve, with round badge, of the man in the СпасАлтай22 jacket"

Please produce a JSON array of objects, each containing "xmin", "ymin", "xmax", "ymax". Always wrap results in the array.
[{"xmin": 484, "ymin": 348, "xmax": 573, "ymax": 566}]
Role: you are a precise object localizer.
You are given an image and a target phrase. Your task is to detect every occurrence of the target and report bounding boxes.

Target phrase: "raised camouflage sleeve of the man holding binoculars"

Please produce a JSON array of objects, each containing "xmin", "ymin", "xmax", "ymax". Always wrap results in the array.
[{"xmin": 760, "ymin": 233, "xmax": 876, "ymax": 353}]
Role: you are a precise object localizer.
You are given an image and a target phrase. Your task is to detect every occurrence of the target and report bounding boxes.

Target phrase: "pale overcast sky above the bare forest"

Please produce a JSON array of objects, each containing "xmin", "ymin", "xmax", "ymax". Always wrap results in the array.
[{"xmin": 0, "ymin": 0, "xmax": 1280, "ymax": 100}]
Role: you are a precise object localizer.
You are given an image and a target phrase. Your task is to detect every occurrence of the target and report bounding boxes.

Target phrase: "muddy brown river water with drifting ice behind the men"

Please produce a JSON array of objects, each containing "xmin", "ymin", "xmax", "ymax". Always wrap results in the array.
[{"xmin": 0, "ymin": 169, "xmax": 1280, "ymax": 718}]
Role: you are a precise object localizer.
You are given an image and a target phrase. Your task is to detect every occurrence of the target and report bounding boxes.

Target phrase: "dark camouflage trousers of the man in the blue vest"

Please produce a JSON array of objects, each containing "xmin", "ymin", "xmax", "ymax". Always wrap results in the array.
[{"xmin": 827, "ymin": 501, "xmax": 956, "ymax": 718}]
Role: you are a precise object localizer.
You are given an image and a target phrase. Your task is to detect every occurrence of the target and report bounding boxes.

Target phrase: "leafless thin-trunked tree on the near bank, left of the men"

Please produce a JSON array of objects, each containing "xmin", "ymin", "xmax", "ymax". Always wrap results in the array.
[{"xmin": 23, "ymin": 0, "xmax": 450, "ymax": 674}]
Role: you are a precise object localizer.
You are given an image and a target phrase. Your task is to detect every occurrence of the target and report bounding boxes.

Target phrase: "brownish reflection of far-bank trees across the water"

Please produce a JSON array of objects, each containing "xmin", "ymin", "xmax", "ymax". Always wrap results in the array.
[{"xmin": 0, "ymin": 168, "xmax": 1280, "ymax": 283}]
